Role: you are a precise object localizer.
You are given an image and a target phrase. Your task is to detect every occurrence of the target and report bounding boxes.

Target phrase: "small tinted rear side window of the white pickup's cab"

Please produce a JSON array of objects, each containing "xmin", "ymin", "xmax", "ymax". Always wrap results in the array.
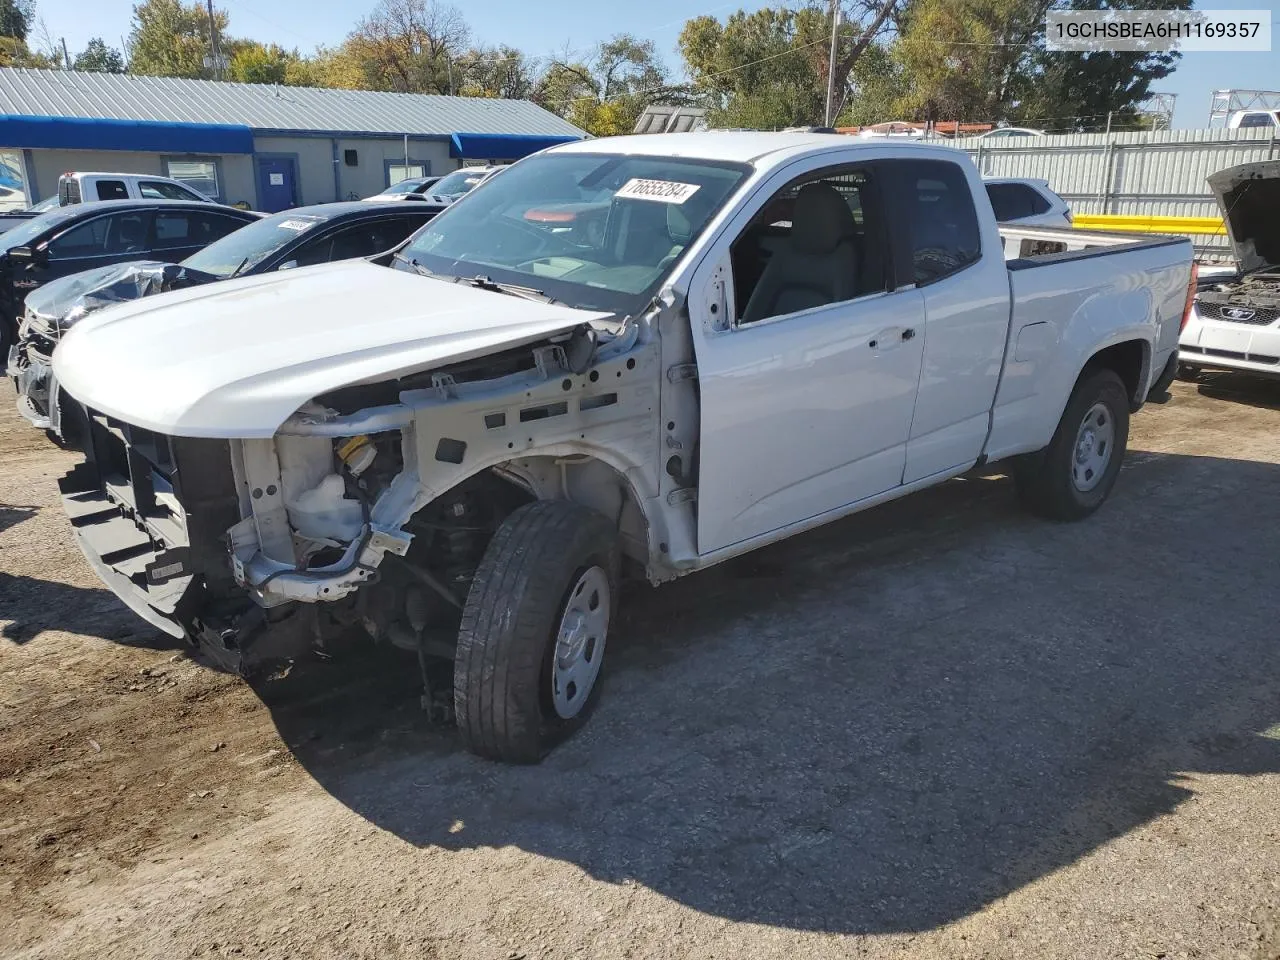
[{"xmin": 893, "ymin": 160, "xmax": 982, "ymax": 284}]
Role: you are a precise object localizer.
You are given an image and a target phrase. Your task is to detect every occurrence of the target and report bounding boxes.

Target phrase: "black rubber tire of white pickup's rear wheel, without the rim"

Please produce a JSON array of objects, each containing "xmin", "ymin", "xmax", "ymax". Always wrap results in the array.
[{"xmin": 1014, "ymin": 370, "xmax": 1129, "ymax": 521}]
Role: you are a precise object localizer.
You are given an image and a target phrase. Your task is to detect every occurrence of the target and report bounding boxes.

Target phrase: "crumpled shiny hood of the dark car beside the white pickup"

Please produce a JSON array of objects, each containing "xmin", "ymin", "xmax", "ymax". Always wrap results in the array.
[{"xmin": 27, "ymin": 260, "xmax": 221, "ymax": 337}]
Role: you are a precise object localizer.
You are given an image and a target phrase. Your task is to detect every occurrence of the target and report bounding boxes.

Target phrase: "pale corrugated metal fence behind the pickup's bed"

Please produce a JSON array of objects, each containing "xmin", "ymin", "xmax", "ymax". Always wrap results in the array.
[{"xmin": 936, "ymin": 128, "xmax": 1280, "ymax": 261}]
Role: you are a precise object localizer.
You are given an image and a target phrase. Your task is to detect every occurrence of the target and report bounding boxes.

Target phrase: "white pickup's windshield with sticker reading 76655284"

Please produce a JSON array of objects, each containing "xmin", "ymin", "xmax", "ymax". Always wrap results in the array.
[{"xmin": 401, "ymin": 152, "xmax": 750, "ymax": 312}]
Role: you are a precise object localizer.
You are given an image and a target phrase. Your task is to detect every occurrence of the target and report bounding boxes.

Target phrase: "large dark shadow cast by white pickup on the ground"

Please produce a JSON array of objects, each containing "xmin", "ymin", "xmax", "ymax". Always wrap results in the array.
[{"xmin": 257, "ymin": 453, "xmax": 1280, "ymax": 933}]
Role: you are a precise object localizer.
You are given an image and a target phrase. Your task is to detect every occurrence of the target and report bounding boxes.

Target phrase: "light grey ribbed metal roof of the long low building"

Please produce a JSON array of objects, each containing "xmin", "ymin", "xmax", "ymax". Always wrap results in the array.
[{"xmin": 0, "ymin": 67, "xmax": 584, "ymax": 137}]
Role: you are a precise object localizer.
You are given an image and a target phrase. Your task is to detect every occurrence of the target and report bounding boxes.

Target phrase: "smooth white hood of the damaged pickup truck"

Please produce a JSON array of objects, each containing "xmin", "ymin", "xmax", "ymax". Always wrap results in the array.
[{"xmin": 54, "ymin": 260, "xmax": 609, "ymax": 438}]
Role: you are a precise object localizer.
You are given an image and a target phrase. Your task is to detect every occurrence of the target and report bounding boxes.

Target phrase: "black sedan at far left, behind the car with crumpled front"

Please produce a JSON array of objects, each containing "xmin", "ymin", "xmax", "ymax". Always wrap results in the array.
[{"xmin": 0, "ymin": 200, "xmax": 260, "ymax": 360}]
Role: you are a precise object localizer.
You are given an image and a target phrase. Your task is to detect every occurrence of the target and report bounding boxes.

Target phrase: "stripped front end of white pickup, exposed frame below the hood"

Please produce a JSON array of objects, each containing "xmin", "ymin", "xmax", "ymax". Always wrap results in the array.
[{"xmin": 61, "ymin": 309, "xmax": 662, "ymax": 672}]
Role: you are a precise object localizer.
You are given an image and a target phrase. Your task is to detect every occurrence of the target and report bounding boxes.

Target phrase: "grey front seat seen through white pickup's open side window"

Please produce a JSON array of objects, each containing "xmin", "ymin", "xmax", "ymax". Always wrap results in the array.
[{"xmin": 742, "ymin": 183, "xmax": 858, "ymax": 324}]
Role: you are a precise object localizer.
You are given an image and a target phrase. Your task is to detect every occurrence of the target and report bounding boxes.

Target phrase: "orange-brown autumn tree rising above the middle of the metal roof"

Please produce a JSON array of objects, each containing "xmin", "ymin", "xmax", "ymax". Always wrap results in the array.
[{"xmin": 335, "ymin": 0, "xmax": 471, "ymax": 93}]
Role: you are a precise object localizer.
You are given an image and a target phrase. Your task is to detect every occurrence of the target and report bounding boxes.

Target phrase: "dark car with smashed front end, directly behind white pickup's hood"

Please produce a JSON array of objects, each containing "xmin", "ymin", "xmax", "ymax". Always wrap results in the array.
[{"xmin": 0, "ymin": 201, "xmax": 438, "ymax": 442}]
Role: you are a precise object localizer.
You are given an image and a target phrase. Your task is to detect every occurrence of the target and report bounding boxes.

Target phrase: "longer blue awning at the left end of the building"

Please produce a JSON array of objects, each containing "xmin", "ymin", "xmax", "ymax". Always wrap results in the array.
[{"xmin": 0, "ymin": 114, "xmax": 253, "ymax": 154}]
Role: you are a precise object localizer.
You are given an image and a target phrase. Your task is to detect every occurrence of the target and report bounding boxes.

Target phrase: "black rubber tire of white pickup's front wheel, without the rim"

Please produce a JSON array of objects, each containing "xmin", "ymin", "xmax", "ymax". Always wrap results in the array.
[{"xmin": 453, "ymin": 500, "xmax": 618, "ymax": 763}]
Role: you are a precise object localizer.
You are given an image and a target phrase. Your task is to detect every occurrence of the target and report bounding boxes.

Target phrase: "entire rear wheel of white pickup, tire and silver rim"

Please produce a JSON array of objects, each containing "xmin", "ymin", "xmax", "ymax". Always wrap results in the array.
[{"xmin": 1014, "ymin": 370, "xmax": 1129, "ymax": 520}]
